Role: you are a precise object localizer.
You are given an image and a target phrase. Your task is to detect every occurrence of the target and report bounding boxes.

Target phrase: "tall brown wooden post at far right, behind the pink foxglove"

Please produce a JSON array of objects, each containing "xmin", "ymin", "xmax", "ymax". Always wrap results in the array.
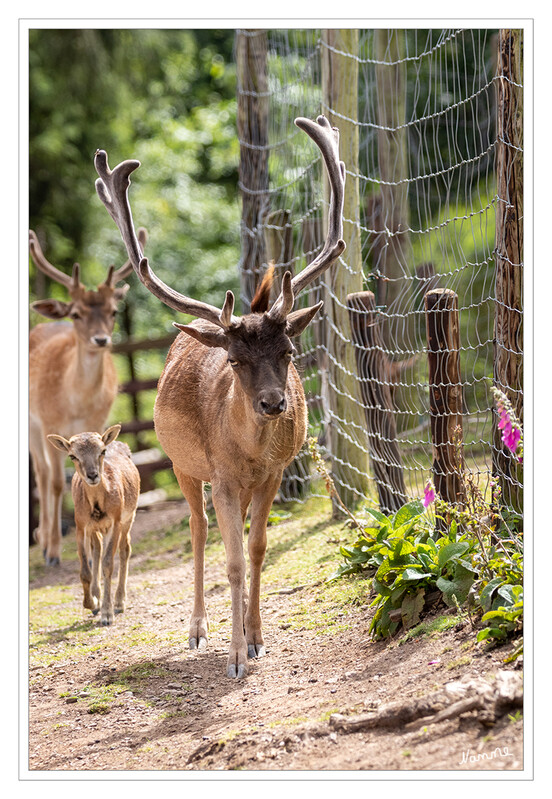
[{"xmin": 493, "ymin": 29, "xmax": 523, "ymax": 512}]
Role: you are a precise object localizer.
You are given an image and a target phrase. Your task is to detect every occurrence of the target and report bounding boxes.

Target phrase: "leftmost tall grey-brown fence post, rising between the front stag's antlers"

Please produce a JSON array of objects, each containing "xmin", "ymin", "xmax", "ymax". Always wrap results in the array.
[{"xmin": 236, "ymin": 29, "xmax": 269, "ymax": 314}]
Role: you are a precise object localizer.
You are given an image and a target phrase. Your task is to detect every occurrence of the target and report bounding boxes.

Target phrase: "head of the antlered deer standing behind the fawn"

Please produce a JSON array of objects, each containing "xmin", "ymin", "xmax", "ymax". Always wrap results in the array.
[{"xmin": 29, "ymin": 228, "xmax": 147, "ymax": 351}]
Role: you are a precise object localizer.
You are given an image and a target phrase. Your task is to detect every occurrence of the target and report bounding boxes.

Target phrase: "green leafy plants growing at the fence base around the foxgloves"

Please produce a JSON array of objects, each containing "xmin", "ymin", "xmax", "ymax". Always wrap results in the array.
[{"xmin": 330, "ymin": 440, "xmax": 523, "ymax": 661}]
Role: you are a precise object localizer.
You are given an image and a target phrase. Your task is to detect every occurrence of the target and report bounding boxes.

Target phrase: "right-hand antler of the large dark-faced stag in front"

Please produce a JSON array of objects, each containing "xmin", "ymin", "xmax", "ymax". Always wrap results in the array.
[{"xmin": 268, "ymin": 115, "xmax": 346, "ymax": 318}]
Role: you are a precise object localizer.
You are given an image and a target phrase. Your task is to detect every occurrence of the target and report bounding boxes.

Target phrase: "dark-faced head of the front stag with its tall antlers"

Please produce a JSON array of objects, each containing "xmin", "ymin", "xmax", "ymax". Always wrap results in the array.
[{"xmin": 94, "ymin": 116, "xmax": 345, "ymax": 419}]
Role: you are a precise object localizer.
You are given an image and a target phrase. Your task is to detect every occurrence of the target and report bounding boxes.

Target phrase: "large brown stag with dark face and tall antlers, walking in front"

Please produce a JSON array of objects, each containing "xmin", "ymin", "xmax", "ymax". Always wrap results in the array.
[{"xmin": 94, "ymin": 116, "xmax": 345, "ymax": 679}]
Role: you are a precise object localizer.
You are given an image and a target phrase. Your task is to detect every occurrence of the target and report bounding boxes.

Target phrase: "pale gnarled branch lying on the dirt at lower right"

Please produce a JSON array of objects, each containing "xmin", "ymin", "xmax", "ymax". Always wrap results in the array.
[{"xmin": 330, "ymin": 671, "xmax": 523, "ymax": 733}]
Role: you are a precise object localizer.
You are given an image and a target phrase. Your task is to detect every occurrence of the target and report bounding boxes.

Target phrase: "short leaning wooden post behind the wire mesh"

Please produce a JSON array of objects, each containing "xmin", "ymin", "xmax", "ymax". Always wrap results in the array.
[{"xmin": 347, "ymin": 291, "xmax": 406, "ymax": 513}]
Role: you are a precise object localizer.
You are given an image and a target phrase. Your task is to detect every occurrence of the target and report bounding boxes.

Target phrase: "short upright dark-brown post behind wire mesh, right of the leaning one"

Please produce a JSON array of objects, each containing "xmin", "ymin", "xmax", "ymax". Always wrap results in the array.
[{"xmin": 425, "ymin": 289, "xmax": 464, "ymax": 507}]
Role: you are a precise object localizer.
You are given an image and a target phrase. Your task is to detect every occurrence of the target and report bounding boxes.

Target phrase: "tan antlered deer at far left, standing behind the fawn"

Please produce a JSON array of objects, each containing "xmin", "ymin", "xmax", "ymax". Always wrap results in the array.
[{"xmin": 29, "ymin": 228, "xmax": 147, "ymax": 566}]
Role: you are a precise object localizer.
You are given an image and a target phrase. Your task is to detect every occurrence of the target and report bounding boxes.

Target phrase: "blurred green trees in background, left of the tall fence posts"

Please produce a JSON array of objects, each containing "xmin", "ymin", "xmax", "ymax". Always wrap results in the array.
[{"xmin": 29, "ymin": 29, "xmax": 239, "ymax": 330}]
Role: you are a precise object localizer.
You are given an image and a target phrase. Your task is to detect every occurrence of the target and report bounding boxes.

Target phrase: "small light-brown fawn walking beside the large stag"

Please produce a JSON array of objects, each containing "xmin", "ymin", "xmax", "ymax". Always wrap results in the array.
[{"xmin": 48, "ymin": 424, "xmax": 140, "ymax": 626}]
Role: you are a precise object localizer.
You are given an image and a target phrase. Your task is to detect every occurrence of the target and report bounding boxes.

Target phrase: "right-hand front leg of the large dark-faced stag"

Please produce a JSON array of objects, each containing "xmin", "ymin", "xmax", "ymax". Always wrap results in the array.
[{"xmin": 245, "ymin": 473, "xmax": 282, "ymax": 658}]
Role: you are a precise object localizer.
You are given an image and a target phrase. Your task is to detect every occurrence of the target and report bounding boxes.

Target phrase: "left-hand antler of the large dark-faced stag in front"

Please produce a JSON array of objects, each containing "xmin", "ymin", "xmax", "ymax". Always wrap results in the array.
[{"xmin": 94, "ymin": 150, "xmax": 237, "ymax": 328}]
